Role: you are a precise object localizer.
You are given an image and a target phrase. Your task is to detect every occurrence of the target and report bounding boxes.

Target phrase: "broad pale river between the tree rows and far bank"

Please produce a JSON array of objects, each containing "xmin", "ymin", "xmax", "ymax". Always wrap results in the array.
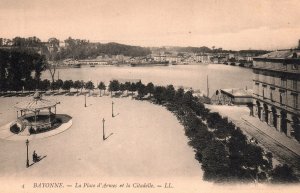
[{"xmin": 42, "ymin": 64, "xmax": 252, "ymax": 96}]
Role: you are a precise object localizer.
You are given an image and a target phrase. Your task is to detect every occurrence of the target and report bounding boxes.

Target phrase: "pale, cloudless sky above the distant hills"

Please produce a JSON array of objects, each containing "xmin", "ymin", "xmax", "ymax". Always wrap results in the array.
[{"xmin": 0, "ymin": 0, "xmax": 300, "ymax": 50}]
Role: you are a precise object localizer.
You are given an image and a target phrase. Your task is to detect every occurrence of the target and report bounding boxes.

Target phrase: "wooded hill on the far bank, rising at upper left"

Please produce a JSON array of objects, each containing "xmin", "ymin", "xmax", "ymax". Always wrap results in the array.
[{"xmin": 0, "ymin": 36, "xmax": 151, "ymax": 61}]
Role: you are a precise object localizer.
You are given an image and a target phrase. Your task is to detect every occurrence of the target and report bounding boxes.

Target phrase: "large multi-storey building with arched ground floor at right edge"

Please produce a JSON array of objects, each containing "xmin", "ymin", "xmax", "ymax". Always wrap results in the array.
[{"xmin": 251, "ymin": 50, "xmax": 300, "ymax": 141}]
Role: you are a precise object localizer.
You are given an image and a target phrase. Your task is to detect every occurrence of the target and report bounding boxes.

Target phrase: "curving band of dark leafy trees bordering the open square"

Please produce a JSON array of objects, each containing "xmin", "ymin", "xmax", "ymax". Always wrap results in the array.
[{"xmin": 2, "ymin": 74, "xmax": 298, "ymax": 183}]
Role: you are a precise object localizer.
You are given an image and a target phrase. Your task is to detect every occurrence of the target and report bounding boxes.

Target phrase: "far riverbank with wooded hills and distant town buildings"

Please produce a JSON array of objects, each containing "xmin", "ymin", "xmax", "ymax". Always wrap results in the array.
[{"xmin": 0, "ymin": 37, "xmax": 276, "ymax": 68}]
